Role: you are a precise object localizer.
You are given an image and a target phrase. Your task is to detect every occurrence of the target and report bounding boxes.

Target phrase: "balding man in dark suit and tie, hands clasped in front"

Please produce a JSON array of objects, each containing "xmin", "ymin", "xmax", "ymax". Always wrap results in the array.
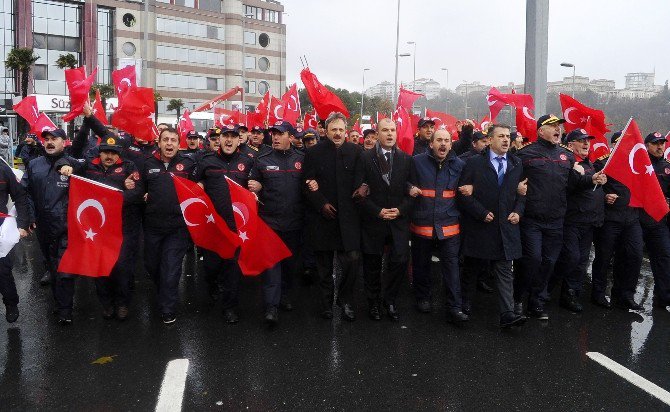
[{"xmin": 356, "ymin": 119, "xmax": 412, "ymax": 321}]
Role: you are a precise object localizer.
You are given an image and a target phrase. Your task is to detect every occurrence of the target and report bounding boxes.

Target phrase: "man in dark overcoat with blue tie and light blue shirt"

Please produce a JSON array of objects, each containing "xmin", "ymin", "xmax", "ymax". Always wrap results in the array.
[{"xmin": 457, "ymin": 125, "xmax": 525, "ymax": 327}]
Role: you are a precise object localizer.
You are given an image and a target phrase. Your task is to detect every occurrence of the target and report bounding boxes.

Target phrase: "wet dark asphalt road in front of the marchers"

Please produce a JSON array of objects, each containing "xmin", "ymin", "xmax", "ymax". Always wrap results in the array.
[{"xmin": 0, "ymin": 237, "xmax": 670, "ymax": 411}]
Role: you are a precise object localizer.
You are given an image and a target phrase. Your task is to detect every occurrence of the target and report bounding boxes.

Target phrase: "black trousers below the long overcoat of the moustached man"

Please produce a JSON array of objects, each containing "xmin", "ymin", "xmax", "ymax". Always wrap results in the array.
[{"xmin": 314, "ymin": 250, "xmax": 360, "ymax": 310}]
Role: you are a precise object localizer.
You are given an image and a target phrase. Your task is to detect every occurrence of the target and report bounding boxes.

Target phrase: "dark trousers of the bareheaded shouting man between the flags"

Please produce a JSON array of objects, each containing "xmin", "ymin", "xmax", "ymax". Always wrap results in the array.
[{"xmin": 144, "ymin": 227, "xmax": 189, "ymax": 314}]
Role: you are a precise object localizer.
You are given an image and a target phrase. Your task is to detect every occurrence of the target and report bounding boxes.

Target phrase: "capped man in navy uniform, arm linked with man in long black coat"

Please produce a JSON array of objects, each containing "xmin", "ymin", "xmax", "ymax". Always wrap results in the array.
[{"xmin": 249, "ymin": 122, "xmax": 305, "ymax": 322}]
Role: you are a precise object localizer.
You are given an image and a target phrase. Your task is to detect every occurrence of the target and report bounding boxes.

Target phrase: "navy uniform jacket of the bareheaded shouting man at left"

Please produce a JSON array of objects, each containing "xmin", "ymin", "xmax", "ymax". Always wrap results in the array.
[{"xmin": 141, "ymin": 152, "xmax": 196, "ymax": 229}]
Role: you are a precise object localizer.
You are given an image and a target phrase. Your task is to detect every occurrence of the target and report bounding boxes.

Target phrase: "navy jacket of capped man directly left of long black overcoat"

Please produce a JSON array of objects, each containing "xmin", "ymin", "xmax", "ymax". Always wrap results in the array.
[{"xmin": 250, "ymin": 148, "xmax": 305, "ymax": 232}]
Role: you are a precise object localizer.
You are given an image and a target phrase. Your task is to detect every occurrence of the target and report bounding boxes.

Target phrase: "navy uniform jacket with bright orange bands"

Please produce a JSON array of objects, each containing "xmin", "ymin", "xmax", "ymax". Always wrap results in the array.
[{"xmin": 410, "ymin": 151, "xmax": 465, "ymax": 239}]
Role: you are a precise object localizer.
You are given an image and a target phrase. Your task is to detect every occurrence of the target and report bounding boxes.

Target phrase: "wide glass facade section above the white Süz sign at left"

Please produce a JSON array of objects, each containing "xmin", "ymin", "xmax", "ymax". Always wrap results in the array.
[{"xmin": 33, "ymin": 0, "xmax": 82, "ymax": 95}]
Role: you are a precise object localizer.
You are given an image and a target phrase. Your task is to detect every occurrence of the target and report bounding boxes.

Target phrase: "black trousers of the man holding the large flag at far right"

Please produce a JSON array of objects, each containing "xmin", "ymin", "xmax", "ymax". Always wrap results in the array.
[{"xmin": 591, "ymin": 221, "xmax": 642, "ymax": 299}]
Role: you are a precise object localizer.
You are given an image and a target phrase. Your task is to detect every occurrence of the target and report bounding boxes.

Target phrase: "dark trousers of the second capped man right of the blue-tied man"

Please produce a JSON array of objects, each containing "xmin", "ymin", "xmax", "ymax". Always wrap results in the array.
[{"xmin": 547, "ymin": 224, "xmax": 594, "ymax": 296}]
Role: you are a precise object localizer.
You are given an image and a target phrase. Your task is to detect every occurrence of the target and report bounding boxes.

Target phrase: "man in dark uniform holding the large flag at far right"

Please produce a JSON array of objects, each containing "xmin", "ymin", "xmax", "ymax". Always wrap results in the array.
[{"xmin": 591, "ymin": 132, "xmax": 643, "ymax": 310}]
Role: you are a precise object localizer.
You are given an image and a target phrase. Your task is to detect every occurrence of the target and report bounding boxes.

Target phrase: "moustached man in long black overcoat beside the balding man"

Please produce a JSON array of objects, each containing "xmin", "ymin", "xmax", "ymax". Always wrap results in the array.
[{"xmin": 303, "ymin": 112, "xmax": 362, "ymax": 321}]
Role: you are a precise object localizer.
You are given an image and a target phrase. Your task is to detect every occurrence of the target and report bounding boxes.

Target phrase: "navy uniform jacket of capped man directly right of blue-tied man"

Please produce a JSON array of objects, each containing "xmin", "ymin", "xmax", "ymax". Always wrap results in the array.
[{"xmin": 516, "ymin": 138, "xmax": 593, "ymax": 222}]
